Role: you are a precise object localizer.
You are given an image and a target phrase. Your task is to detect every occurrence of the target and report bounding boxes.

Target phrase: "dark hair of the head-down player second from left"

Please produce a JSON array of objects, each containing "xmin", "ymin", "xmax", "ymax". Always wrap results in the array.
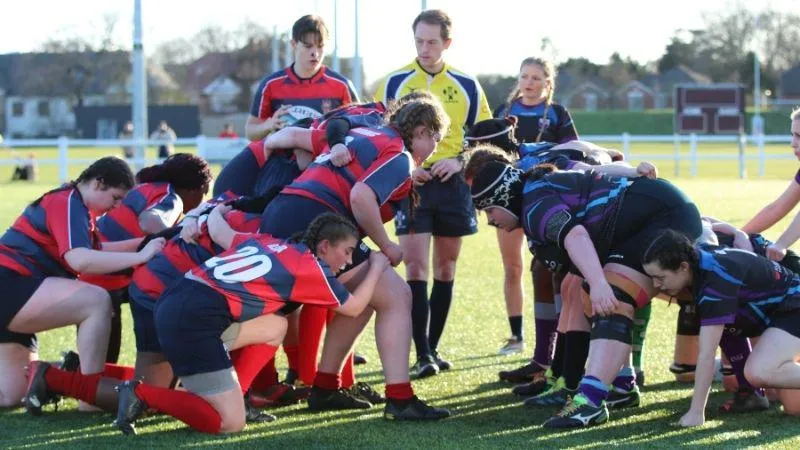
[{"xmin": 136, "ymin": 153, "xmax": 211, "ymax": 190}]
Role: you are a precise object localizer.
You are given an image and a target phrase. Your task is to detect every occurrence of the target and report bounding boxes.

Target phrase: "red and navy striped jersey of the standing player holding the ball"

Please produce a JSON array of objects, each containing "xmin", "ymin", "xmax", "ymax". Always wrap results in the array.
[{"xmin": 250, "ymin": 65, "xmax": 358, "ymax": 120}]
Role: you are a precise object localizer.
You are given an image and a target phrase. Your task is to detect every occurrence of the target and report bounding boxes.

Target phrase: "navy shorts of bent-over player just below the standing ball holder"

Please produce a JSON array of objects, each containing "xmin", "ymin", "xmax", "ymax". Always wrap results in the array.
[{"xmin": 213, "ymin": 148, "xmax": 300, "ymax": 197}]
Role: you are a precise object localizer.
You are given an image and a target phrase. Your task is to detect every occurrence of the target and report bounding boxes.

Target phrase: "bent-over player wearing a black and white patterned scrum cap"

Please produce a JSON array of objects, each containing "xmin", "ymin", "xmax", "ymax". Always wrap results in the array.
[{"xmin": 466, "ymin": 148, "xmax": 701, "ymax": 428}]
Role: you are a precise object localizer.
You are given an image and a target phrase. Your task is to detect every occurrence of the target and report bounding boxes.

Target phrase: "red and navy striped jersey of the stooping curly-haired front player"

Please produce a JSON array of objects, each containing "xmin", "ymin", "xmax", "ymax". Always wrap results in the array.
[{"xmin": 282, "ymin": 127, "xmax": 414, "ymax": 223}]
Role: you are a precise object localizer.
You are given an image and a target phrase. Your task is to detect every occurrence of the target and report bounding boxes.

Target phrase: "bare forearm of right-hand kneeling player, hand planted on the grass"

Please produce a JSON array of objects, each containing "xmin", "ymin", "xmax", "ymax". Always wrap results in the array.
[{"xmin": 680, "ymin": 325, "xmax": 725, "ymax": 427}]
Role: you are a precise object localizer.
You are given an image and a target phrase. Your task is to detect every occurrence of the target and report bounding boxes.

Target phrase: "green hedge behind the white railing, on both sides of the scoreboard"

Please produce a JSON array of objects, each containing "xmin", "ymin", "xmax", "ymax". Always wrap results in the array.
[{"xmin": 570, "ymin": 110, "xmax": 789, "ymax": 135}]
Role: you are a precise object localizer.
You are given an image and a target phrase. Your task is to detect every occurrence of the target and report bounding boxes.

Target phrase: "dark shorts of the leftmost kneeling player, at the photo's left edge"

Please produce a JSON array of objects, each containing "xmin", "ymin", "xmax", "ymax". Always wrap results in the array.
[{"xmin": 0, "ymin": 267, "xmax": 46, "ymax": 353}]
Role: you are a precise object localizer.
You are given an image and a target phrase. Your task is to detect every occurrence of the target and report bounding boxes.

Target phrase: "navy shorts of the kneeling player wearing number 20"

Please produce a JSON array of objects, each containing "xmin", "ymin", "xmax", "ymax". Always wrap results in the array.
[{"xmin": 155, "ymin": 279, "xmax": 233, "ymax": 377}]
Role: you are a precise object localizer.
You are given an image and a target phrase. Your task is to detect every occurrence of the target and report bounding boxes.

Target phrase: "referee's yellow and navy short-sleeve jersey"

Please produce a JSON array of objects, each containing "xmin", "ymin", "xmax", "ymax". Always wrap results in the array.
[{"xmin": 375, "ymin": 59, "xmax": 492, "ymax": 167}]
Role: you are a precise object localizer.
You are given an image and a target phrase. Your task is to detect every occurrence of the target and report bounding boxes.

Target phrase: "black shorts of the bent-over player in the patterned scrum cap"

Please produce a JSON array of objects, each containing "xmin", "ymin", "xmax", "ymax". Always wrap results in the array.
[{"xmin": 602, "ymin": 178, "xmax": 702, "ymax": 273}]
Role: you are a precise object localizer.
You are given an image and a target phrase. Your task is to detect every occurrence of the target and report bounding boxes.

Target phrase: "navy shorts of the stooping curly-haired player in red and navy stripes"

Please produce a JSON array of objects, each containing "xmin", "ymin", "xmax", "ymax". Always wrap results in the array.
[{"xmin": 259, "ymin": 194, "xmax": 371, "ymax": 273}]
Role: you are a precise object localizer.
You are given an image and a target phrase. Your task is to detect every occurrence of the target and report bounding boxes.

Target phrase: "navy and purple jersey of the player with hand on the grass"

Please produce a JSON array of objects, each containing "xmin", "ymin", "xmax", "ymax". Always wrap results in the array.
[{"xmin": 692, "ymin": 245, "xmax": 800, "ymax": 331}]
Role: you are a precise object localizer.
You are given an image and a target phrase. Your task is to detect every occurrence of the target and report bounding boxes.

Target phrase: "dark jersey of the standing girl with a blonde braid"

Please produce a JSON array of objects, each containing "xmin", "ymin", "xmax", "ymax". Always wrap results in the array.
[{"xmin": 494, "ymin": 98, "xmax": 578, "ymax": 144}]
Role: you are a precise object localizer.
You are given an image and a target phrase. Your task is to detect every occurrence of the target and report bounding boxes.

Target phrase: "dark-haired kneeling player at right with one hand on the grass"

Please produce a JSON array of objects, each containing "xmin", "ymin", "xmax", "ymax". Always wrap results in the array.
[{"xmin": 642, "ymin": 230, "xmax": 800, "ymax": 427}]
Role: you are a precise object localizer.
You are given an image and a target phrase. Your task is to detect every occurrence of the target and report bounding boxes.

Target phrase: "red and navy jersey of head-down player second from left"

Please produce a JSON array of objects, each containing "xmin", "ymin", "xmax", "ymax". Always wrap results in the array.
[{"xmin": 97, "ymin": 183, "xmax": 183, "ymax": 242}]
